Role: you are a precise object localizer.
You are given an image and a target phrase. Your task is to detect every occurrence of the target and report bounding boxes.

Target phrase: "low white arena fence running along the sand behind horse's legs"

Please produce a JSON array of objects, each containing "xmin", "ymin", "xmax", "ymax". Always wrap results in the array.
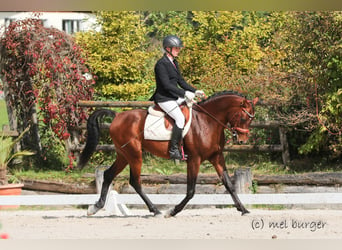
[{"xmin": 0, "ymin": 191, "xmax": 342, "ymax": 215}]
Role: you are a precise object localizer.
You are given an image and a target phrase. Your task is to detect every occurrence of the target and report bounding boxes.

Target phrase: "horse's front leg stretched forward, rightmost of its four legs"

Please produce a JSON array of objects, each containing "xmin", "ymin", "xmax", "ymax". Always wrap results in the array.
[{"xmin": 210, "ymin": 153, "xmax": 249, "ymax": 215}]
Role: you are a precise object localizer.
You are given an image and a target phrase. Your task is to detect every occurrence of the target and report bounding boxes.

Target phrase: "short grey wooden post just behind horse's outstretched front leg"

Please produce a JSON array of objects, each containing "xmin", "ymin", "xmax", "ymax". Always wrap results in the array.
[{"xmin": 234, "ymin": 168, "xmax": 253, "ymax": 194}]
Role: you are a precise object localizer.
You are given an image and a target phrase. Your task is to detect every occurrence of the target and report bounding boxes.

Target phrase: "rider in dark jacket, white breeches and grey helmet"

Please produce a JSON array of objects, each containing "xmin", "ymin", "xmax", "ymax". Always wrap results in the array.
[{"xmin": 151, "ymin": 35, "xmax": 204, "ymax": 160}]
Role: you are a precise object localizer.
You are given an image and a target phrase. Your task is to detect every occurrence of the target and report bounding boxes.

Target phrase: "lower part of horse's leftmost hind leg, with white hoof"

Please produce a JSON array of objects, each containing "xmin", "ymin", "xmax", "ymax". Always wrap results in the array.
[{"xmin": 87, "ymin": 154, "xmax": 127, "ymax": 215}]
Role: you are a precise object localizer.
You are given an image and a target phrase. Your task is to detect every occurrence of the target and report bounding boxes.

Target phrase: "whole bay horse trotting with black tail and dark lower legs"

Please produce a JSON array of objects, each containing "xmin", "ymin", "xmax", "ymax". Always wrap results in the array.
[{"xmin": 78, "ymin": 91, "xmax": 258, "ymax": 217}]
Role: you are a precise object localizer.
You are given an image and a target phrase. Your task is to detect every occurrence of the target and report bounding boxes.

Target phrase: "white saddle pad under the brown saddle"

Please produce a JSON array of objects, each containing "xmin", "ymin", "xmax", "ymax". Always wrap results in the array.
[{"xmin": 144, "ymin": 107, "xmax": 192, "ymax": 141}]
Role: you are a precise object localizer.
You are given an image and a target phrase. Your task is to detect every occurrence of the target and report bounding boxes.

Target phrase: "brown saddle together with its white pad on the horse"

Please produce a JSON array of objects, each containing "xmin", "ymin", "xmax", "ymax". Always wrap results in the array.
[{"xmin": 144, "ymin": 103, "xmax": 192, "ymax": 141}]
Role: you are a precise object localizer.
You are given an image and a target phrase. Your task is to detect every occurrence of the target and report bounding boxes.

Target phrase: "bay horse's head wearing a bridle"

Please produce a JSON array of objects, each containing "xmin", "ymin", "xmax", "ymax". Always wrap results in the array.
[{"xmin": 230, "ymin": 97, "xmax": 259, "ymax": 144}]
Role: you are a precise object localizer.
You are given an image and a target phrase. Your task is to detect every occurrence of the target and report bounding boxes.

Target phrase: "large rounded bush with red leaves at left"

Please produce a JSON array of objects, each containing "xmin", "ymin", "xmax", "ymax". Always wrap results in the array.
[{"xmin": 0, "ymin": 18, "xmax": 94, "ymax": 169}]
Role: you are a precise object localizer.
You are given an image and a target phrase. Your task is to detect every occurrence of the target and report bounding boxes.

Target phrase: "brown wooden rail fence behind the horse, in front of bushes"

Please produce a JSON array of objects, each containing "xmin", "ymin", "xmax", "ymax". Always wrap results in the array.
[{"xmin": 67, "ymin": 101, "xmax": 290, "ymax": 165}]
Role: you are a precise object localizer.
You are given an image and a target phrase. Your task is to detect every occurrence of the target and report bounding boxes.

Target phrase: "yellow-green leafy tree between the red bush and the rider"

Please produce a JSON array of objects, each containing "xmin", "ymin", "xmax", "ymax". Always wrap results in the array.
[{"xmin": 77, "ymin": 11, "xmax": 155, "ymax": 98}]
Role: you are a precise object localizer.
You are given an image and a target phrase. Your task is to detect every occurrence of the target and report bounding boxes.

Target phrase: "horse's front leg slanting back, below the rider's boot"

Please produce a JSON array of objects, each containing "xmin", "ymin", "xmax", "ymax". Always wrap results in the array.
[{"xmin": 165, "ymin": 159, "xmax": 200, "ymax": 217}]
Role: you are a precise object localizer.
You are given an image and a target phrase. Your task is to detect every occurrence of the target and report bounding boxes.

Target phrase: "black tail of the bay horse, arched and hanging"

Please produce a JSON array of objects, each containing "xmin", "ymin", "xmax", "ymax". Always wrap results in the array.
[{"xmin": 77, "ymin": 109, "xmax": 116, "ymax": 169}]
